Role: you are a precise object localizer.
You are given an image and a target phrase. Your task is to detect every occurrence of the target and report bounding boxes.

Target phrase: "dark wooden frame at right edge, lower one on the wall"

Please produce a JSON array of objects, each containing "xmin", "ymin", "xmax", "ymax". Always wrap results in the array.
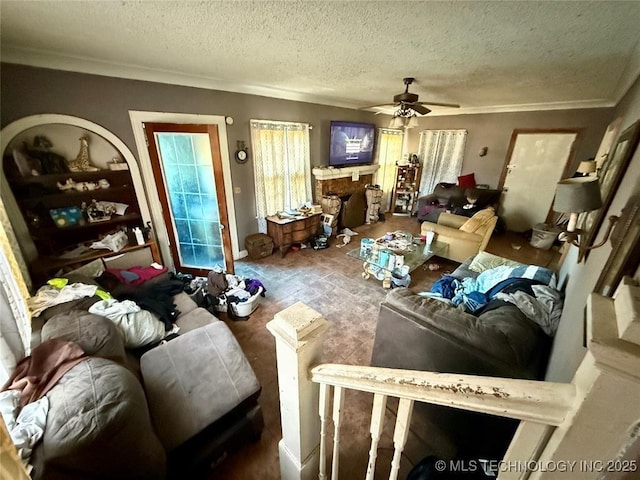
[{"xmin": 594, "ymin": 193, "xmax": 640, "ymax": 297}]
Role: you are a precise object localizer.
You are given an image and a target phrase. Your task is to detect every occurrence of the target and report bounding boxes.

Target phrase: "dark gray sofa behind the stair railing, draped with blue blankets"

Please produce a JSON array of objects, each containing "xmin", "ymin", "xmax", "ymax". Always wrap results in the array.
[{"xmin": 371, "ymin": 259, "xmax": 551, "ymax": 459}]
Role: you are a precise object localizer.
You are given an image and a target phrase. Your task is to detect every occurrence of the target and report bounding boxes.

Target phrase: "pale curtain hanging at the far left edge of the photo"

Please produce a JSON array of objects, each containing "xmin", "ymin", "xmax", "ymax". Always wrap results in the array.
[{"xmin": 0, "ymin": 200, "xmax": 31, "ymax": 385}]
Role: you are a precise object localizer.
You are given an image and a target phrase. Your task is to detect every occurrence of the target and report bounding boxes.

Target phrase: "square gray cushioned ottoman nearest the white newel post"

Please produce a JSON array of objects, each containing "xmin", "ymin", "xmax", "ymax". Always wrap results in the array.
[{"xmin": 140, "ymin": 321, "xmax": 263, "ymax": 474}]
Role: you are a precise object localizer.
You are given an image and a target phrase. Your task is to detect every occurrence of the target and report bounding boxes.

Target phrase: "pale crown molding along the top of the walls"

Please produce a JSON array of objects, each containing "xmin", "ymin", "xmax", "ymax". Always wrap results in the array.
[{"xmin": 2, "ymin": 45, "xmax": 620, "ymax": 118}]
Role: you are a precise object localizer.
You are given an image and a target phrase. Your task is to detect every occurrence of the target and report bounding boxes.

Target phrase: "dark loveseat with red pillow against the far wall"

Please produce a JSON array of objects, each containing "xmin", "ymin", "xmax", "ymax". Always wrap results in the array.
[{"xmin": 416, "ymin": 182, "xmax": 502, "ymax": 223}]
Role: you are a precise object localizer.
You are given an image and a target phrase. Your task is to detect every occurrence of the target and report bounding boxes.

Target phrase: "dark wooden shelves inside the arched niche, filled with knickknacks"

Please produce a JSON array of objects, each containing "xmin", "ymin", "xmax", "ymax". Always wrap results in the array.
[{"xmin": 2, "ymin": 123, "xmax": 162, "ymax": 285}]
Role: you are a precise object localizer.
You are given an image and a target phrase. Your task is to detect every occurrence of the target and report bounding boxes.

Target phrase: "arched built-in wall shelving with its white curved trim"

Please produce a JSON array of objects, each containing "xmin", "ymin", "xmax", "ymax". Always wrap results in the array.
[{"xmin": 0, "ymin": 114, "xmax": 159, "ymax": 284}]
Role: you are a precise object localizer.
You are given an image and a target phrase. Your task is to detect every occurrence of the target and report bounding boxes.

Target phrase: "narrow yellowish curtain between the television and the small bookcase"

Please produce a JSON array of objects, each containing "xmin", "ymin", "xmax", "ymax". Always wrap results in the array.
[{"xmin": 375, "ymin": 128, "xmax": 404, "ymax": 212}]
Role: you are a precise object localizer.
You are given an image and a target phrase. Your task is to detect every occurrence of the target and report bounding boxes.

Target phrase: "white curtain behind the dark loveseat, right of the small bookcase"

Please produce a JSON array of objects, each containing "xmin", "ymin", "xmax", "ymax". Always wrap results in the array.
[{"xmin": 418, "ymin": 130, "xmax": 467, "ymax": 195}]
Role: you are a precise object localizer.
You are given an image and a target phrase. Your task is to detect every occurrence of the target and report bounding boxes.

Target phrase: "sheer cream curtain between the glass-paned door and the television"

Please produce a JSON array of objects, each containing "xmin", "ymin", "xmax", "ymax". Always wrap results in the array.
[{"xmin": 251, "ymin": 120, "xmax": 311, "ymax": 233}]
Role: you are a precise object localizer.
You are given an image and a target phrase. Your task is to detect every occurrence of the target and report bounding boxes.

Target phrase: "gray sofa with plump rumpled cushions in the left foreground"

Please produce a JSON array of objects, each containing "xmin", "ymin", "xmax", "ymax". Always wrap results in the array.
[{"xmin": 8, "ymin": 280, "xmax": 263, "ymax": 480}]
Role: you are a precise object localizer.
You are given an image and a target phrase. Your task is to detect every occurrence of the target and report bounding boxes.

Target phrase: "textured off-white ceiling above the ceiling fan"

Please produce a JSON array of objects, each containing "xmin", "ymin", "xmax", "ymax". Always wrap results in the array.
[{"xmin": 0, "ymin": 0, "xmax": 640, "ymax": 114}]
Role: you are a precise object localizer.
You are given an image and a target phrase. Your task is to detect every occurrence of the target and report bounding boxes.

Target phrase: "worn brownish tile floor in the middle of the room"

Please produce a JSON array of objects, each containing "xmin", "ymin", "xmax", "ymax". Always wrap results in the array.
[{"xmin": 208, "ymin": 217, "xmax": 558, "ymax": 480}]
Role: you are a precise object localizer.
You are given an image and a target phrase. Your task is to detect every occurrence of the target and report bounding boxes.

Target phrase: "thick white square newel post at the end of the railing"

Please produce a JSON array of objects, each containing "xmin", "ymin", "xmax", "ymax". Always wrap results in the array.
[{"xmin": 267, "ymin": 302, "xmax": 329, "ymax": 480}]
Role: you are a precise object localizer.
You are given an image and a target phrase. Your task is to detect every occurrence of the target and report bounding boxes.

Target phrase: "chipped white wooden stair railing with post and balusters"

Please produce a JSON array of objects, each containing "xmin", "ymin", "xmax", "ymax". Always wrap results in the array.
[{"xmin": 267, "ymin": 289, "xmax": 640, "ymax": 480}]
